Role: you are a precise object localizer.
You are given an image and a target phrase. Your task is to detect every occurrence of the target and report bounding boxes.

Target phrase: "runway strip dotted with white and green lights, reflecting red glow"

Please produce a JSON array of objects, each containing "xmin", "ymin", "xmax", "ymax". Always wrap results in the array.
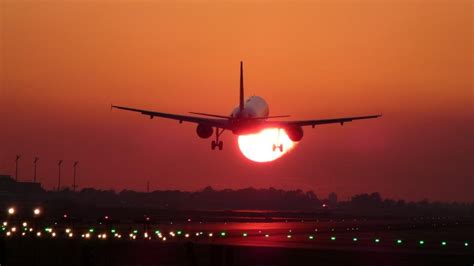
[{"xmin": 2, "ymin": 217, "xmax": 474, "ymax": 254}]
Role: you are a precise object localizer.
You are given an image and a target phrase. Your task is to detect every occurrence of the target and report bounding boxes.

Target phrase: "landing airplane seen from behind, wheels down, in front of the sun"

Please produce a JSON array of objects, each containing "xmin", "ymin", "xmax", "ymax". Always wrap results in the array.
[{"xmin": 111, "ymin": 61, "xmax": 382, "ymax": 152}]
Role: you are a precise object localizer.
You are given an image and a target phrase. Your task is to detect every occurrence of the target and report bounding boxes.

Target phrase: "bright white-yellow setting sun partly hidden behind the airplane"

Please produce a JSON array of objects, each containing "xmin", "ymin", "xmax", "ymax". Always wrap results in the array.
[{"xmin": 238, "ymin": 128, "xmax": 296, "ymax": 163}]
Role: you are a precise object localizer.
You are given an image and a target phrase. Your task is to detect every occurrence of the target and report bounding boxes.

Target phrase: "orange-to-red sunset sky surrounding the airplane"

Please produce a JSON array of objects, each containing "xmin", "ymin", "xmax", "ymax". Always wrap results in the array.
[{"xmin": 0, "ymin": 0, "xmax": 474, "ymax": 201}]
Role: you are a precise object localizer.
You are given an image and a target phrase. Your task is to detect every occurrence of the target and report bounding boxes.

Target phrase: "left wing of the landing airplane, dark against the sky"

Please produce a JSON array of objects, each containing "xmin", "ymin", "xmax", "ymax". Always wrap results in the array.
[{"xmin": 111, "ymin": 105, "xmax": 230, "ymax": 129}]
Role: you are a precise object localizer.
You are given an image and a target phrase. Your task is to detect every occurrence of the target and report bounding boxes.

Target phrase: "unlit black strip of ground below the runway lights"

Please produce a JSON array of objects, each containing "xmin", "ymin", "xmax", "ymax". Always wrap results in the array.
[{"xmin": 2, "ymin": 239, "xmax": 474, "ymax": 266}]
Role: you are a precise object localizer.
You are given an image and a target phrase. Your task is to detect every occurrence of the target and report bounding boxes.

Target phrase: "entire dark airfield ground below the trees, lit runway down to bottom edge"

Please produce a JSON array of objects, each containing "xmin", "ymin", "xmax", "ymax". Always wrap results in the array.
[{"xmin": 0, "ymin": 218, "xmax": 474, "ymax": 266}]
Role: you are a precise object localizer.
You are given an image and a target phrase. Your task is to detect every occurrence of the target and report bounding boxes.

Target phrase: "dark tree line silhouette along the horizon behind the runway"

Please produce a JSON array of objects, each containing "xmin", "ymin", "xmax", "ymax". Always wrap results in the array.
[{"xmin": 0, "ymin": 186, "xmax": 474, "ymax": 217}]
